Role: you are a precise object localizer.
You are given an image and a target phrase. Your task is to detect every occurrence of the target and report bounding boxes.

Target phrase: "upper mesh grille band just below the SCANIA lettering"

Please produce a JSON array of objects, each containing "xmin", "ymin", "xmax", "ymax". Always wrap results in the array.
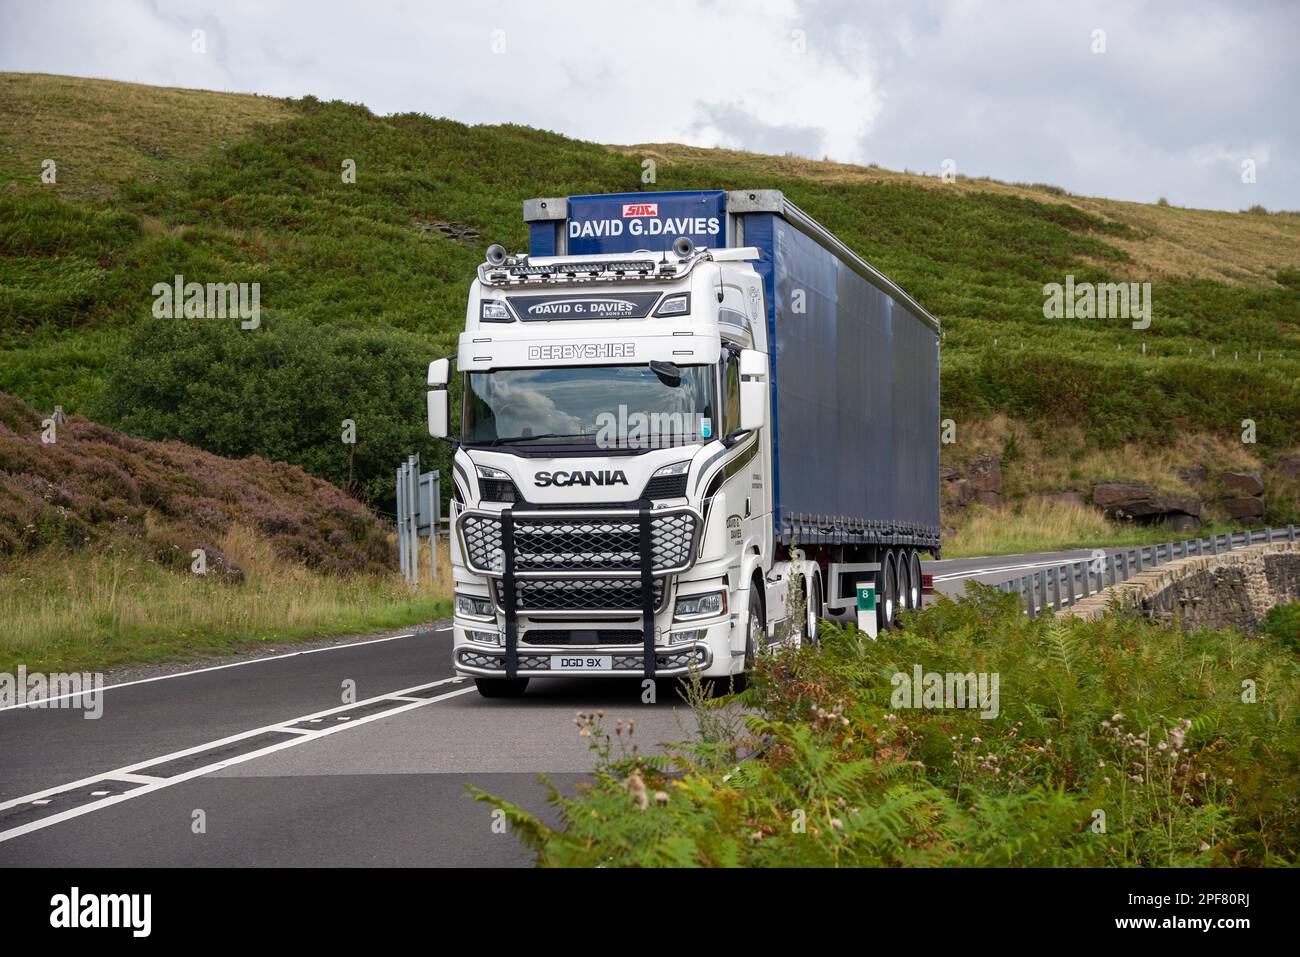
[{"xmin": 460, "ymin": 510, "xmax": 699, "ymax": 576}]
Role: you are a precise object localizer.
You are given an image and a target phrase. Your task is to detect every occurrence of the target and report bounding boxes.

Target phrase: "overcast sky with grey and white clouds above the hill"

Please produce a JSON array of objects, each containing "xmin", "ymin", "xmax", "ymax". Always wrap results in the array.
[{"xmin": 0, "ymin": 0, "xmax": 1300, "ymax": 209}]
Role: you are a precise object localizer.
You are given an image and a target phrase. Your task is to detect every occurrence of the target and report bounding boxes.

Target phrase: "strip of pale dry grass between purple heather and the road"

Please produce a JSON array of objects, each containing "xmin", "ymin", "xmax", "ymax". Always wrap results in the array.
[{"xmin": 0, "ymin": 527, "xmax": 451, "ymax": 671}]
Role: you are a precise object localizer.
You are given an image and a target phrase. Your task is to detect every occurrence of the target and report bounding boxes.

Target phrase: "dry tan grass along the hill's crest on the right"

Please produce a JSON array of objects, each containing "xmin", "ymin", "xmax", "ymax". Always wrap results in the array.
[{"xmin": 608, "ymin": 143, "xmax": 1300, "ymax": 285}]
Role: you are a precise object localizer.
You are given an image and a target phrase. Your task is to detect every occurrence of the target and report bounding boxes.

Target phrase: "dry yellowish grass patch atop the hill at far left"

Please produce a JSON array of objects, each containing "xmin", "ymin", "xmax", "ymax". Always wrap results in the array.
[{"xmin": 0, "ymin": 73, "xmax": 295, "ymax": 199}]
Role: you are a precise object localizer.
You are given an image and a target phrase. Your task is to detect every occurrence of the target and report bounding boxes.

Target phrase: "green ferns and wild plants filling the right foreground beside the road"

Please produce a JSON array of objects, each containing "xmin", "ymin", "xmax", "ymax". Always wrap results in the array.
[{"xmin": 476, "ymin": 586, "xmax": 1300, "ymax": 867}]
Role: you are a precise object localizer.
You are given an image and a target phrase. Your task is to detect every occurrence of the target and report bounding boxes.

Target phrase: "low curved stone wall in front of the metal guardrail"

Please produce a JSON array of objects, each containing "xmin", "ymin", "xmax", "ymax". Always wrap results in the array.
[{"xmin": 1061, "ymin": 542, "xmax": 1300, "ymax": 635}]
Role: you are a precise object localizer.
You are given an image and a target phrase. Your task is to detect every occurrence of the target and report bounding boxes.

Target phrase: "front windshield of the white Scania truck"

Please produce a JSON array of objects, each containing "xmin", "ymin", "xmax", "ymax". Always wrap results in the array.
[{"xmin": 464, "ymin": 363, "xmax": 716, "ymax": 449}]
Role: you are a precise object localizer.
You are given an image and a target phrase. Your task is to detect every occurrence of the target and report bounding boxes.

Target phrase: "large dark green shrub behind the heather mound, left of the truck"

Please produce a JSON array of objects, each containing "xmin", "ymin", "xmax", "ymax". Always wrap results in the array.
[{"xmin": 103, "ymin": 315, "xmax": 447, "ymax": 508}]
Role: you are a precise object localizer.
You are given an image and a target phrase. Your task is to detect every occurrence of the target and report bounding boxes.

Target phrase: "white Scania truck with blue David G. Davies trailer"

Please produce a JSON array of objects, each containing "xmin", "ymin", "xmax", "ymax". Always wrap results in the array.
[{"xmin": 428, "ymin": 190, "xmax": 940, "ymax": 697}]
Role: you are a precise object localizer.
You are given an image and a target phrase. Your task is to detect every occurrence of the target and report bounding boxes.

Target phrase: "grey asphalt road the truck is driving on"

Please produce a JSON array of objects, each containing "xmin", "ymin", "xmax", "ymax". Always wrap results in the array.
[{"xmin": 0, "ymin": 550, "xmax": 1118, "ymax": 867}]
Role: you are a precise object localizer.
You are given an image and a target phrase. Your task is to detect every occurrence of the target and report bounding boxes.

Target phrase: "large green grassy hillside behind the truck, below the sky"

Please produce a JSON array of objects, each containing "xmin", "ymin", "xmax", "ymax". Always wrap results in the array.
[{"xmin": 0, "ymin": 74, "xmax": 1300, "ymax": 547}]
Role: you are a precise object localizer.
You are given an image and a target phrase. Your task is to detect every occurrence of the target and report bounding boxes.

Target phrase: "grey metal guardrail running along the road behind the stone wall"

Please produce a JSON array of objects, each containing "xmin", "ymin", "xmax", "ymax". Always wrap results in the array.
[{"xmin": 997, "ymin": 525, "xmax": 1296, "ymax": 618}]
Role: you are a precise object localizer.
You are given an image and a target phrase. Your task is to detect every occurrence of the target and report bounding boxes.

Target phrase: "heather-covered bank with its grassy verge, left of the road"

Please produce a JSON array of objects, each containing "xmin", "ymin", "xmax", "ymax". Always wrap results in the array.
[{"xmin": 0, "ymin": 393, "xmax": 451, "ymax": 671}]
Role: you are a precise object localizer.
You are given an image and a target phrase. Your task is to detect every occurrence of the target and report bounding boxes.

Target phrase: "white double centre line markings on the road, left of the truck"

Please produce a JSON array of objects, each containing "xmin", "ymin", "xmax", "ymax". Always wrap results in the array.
[{"xmin": 0, "ymin": 676, "xmax": 475, "ymax": 844}]
